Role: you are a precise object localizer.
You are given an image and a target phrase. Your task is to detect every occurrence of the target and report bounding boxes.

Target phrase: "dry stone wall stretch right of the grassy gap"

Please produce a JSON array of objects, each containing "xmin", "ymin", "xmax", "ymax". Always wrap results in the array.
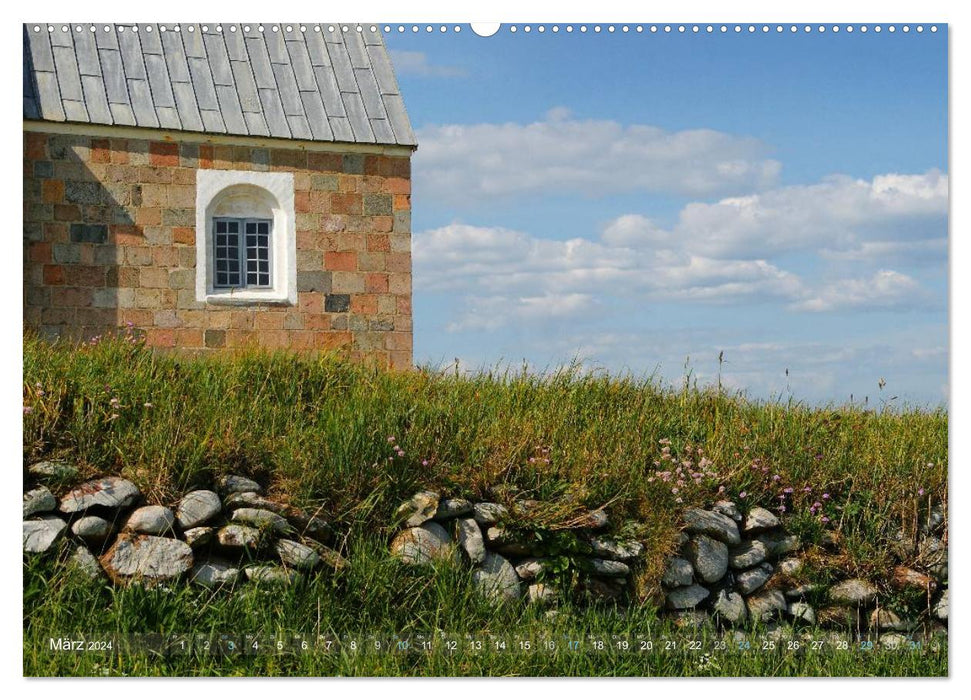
[{"xmin": 391, "ymin": 491, "xmax": 949, "ymax": 644}]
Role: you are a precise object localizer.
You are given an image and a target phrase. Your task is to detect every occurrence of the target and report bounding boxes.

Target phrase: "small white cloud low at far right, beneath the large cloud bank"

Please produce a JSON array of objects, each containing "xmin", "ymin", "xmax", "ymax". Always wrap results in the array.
[{"xmin": 791, "ymin": 270, "xmax": 929, "ymax": 312}]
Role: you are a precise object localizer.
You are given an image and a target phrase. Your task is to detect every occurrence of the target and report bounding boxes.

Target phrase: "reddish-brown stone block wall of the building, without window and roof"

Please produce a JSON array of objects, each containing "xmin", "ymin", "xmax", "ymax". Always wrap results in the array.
[{"xmin": 24, "ymin": 132, "xmax": 412, "ymax": 368}]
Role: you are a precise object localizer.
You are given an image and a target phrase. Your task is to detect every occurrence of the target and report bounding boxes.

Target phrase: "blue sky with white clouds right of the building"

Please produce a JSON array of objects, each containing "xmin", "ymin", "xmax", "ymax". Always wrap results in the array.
[{"xmin": 386, "ymin": 25, "xmax": 948, "ymax": 405}]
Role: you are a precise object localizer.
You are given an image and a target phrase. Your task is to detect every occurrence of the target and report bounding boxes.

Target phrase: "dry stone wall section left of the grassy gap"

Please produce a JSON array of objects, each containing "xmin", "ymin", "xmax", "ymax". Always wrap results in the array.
[{"xmin": 23, "ymin": 462, "xmax": 348, "ymax": 589}]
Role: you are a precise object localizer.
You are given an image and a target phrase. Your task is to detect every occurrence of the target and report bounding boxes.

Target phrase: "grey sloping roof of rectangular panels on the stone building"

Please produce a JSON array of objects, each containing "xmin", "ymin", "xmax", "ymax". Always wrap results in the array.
[{"xmin": 24, "ymin": 22, "xmax": 417, "ymax": 146}]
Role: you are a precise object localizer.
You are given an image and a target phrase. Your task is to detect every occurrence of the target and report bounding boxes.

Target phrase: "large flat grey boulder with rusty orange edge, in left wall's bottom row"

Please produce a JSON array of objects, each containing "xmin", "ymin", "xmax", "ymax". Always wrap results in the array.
[{"xmin": 101, "ymin": 535, "xmax": 193, "ymax": 583}]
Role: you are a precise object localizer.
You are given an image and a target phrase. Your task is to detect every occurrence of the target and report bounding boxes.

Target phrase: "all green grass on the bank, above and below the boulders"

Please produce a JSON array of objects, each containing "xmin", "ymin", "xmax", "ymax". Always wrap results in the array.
[{"xmin": 24, "ymin": 337, "xmax": 948, "ymax": 675}]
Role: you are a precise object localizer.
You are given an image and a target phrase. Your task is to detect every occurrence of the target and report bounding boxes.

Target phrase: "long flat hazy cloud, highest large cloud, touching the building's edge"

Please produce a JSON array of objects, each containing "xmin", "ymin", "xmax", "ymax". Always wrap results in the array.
[{"xmin": 412, "ymin": 110, "xmax": 780, "ymax": 202}]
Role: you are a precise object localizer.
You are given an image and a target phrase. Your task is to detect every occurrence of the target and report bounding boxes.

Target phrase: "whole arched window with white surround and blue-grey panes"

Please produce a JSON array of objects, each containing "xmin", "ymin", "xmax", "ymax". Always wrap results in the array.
[{"xmin": 196, "ymin": 170, "xmax": 297, "ymax": 305}]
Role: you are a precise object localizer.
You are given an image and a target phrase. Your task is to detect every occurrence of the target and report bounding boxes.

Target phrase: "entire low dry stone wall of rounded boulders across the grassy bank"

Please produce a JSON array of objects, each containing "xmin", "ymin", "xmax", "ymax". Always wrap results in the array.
[{"xmin": 23, "ymin": 470, "xmax": 949, "ymax": 646}]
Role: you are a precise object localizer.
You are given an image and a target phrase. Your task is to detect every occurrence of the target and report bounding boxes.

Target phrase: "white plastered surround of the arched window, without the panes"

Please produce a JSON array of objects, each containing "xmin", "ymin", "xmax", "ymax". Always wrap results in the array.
[{"xmin": 196, "ymin": 169, "xmax": 297, "ymax": 306}]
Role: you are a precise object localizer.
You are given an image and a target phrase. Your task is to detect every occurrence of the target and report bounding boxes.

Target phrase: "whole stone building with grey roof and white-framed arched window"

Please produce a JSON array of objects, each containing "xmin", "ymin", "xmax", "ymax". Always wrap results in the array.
[{"xmin": 23, "ymin": 23, "xmax": 417, "ymax": 368}]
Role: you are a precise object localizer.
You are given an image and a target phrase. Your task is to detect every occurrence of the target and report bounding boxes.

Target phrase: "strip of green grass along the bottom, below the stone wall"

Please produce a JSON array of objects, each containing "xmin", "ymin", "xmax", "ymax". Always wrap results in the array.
[{"xmin": 24, "ymin": 538, "xmax": 947, "ymax": 676}]
